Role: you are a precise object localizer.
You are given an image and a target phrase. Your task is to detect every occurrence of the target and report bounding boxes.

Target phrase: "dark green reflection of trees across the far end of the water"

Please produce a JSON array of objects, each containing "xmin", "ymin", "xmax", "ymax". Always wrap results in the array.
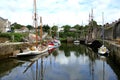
[{"xmin": 59, "ymin": 43, "xmax": 97, "ymax": 61}]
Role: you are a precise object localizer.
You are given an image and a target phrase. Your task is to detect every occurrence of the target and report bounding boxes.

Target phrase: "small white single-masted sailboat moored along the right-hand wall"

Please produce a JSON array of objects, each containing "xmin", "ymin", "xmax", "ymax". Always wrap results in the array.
[{"xmin": 98, "ymin": 13, "xmax": 109, "ymax": 55}]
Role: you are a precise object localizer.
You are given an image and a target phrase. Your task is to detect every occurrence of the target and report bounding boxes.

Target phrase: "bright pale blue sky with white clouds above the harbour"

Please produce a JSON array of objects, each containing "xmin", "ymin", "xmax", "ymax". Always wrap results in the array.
[{"xmin": 0, "ymin": 0, "xmax": 120, "ymax": 27}]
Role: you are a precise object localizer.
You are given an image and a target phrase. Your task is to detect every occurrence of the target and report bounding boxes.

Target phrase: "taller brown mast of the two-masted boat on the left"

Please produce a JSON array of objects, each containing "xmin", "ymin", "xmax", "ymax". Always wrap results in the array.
[{"xmin": 33, "ymin": 0, "xmax": 38, "ymax": 47}]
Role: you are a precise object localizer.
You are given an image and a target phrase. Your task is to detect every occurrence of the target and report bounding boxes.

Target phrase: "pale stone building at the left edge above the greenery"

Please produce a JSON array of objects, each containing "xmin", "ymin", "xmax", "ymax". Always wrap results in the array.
[{"xmin": 0, "ymin": 17, "xmax": 11, "ymax": 33}]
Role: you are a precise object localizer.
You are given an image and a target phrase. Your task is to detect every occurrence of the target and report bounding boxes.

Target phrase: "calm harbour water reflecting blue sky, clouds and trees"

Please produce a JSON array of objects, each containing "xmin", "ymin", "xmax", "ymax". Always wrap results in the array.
[{"xmin": 0, "ymin": 44, "xmax": 120, "ymax": 80}]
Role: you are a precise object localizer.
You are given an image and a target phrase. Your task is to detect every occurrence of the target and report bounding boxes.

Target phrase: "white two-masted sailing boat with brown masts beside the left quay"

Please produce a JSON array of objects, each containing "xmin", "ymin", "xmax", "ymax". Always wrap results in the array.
[{"xmin": 17, "ymin": 0, "xmax": 48, "ymax": 56}]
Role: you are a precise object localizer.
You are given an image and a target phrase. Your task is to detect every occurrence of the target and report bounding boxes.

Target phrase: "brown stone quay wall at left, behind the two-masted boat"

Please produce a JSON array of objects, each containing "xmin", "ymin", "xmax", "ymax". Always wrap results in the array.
[{"xmin": 0, "ymin": 42, "xmax": 29, "ymax": 59}]
